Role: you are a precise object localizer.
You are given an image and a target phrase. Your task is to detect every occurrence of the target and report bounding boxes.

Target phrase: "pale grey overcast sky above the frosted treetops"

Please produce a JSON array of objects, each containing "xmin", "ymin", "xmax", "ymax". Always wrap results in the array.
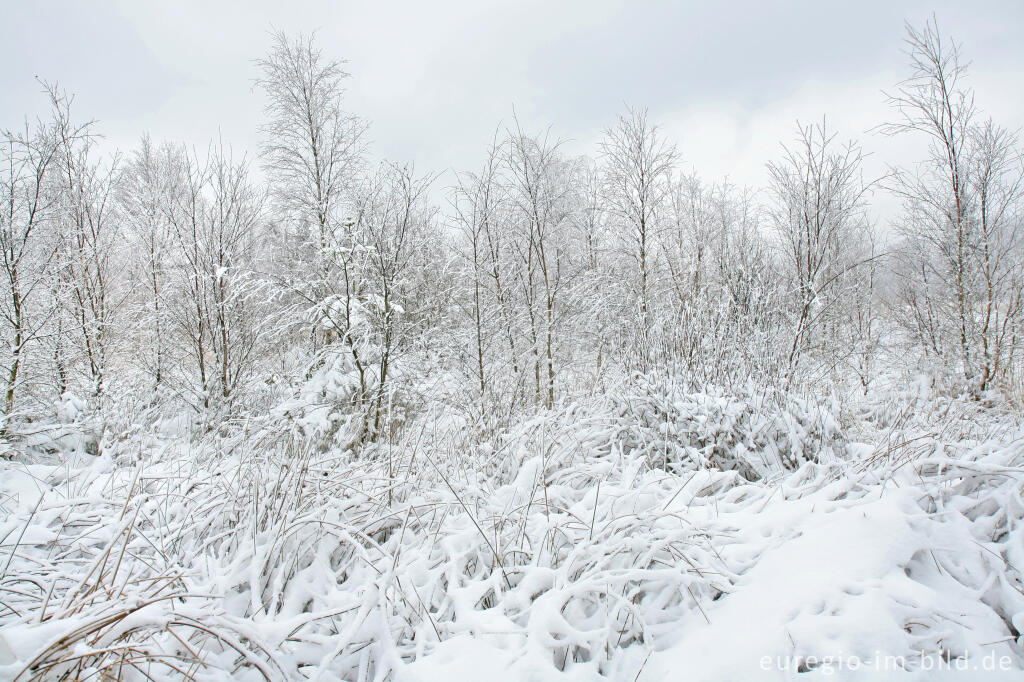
[{"xmin": 0, "ymin": 0, "xmax": 1024, "ymax": 222}]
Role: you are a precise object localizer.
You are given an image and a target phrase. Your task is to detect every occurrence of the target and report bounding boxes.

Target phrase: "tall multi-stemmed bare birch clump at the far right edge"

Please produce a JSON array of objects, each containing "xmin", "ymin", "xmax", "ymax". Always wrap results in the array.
[{"xmin": 883, "ymin": 17, "xmax": 1024, "ymax": 390}]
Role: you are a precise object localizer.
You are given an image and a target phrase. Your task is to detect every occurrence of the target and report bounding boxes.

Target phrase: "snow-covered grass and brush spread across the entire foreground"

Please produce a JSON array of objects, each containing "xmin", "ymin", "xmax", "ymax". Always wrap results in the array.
[{"xmin": 0, "ymin": 387, "xmax": 1024, "ymax": 682}]
